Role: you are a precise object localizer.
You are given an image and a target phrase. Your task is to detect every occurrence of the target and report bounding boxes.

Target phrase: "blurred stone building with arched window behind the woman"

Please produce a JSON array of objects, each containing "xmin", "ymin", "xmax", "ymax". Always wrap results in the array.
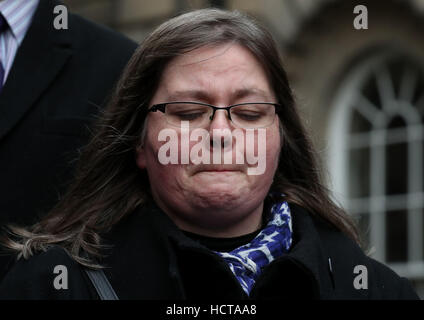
[{"xmin": 65, "ymin": 0, "xmax": 424, "ymax": 297}]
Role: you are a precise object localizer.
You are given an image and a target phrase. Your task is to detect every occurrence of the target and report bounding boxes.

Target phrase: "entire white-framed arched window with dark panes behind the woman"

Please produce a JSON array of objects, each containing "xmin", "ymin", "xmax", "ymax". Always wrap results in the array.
[{"xmin": 329, "ymin": 52, "xmax": 424, "ymax": 278}]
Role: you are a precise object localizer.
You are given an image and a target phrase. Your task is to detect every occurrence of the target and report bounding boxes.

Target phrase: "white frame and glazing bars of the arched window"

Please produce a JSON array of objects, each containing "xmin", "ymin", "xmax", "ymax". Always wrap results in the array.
[{"xmin": 327, "ymin": 51, "xmax": 424, "ymax": 278}]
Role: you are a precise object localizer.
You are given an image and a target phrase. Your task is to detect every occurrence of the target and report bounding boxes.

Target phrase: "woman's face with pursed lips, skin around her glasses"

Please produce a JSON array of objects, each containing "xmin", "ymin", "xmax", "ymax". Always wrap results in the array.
[{"xmin": 137, "ymin": 44, "xmax": 281, "ymax": 237}]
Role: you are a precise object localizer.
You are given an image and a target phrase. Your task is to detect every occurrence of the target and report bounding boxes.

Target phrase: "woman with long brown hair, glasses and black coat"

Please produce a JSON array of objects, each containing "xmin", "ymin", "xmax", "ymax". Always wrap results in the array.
[{"xmin": 0, "ymin": 9, "xmax": 417, "ymax": 299}]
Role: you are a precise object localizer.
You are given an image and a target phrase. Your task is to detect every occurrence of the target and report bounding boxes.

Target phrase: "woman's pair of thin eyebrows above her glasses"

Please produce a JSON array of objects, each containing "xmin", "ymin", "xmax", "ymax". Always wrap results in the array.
[{"xmin": 168, "ymin": 88, "xmax": 272, "ymax": 102}]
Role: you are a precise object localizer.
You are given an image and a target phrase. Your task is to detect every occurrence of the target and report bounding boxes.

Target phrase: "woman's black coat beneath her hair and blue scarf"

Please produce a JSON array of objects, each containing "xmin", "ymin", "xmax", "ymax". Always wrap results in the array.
[{"xmin": 0, "ymin": 204, "xmax": 418, "ymax": 301}]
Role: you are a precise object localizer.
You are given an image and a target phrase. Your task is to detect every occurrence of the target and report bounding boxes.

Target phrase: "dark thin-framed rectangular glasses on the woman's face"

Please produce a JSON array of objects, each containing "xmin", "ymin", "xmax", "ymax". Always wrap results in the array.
[{"xmin": 148, "ymin": 101, "xmax": 282, "ymax": 129}]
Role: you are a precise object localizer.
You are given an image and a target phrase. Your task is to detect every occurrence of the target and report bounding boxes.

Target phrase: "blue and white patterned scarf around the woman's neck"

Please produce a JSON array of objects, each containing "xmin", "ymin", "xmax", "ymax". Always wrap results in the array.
[{"xmin": 215, "ymin": 202, "xmax": 292, "ymax": 295}]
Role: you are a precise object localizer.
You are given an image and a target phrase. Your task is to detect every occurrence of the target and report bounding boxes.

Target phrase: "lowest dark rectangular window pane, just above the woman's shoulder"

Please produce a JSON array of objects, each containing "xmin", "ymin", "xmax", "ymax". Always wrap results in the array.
[{"xmin": 386, "ymin": 210, "xmax": 408, "ymax": 262}]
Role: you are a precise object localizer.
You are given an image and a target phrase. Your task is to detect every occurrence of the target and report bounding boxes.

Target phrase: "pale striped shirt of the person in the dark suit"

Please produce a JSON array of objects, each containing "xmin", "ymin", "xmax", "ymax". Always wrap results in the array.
[{"xmin": 0, "ymin": 0, "xmax": 39, "ymax": 44}]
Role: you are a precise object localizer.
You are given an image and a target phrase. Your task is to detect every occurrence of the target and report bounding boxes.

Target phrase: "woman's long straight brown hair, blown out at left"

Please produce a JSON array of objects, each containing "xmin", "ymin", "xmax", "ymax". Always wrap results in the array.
[{"xmin": 3, "ymin": 9, "xmax": 358, "ymax": 267}]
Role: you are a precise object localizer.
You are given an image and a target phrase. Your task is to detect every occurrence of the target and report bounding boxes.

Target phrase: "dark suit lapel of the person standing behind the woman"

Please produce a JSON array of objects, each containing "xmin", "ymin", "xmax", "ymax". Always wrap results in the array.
[{"xmin": 0, "ymin": 0, "xmax": 72, "ymax": 140}]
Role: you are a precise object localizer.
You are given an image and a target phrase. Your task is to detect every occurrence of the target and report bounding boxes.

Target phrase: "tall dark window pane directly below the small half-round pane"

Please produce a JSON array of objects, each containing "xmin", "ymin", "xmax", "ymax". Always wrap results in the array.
[{"xmin": 386, "ymin": 143, "xmax": 408, "ymax": 195}]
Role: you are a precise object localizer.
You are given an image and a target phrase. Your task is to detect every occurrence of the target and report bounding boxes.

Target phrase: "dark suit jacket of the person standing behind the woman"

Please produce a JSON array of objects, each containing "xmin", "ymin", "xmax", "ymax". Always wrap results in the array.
[{"xmin": 0, "ymin": 0, "xmax": 136, "ymax": 279}]
